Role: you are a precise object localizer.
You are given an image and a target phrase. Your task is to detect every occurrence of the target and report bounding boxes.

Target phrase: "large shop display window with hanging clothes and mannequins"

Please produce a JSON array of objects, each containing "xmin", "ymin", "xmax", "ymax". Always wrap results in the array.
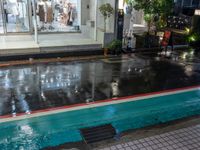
[{"xmin": 36, "ymin": 0, "xmax": 80, "ymax": 32}]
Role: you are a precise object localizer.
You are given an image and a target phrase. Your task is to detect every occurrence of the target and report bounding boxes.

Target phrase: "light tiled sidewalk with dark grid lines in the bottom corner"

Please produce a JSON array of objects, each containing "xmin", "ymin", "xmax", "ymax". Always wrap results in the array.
[{"xmin": 95, "ymin": 124, "xmax": 200, "ymax": 150}]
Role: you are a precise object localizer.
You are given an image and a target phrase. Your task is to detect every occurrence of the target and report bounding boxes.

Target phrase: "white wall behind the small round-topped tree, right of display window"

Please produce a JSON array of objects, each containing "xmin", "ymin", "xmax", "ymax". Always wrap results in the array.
[{"xmin": 81, "ymin": 0, "xmax": 115, "ymax": 42}]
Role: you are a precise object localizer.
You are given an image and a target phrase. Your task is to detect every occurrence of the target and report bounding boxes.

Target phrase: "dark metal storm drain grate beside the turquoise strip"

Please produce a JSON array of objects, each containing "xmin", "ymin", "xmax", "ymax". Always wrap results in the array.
[{"xmin": 80, "ymin": 124, "xmax": 116, "ymax": 144}]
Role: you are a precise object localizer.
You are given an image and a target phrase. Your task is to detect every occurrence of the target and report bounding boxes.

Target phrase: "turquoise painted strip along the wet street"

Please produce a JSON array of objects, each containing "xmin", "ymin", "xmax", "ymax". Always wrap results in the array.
[{"xmin": 0, "ymin": 90, "xmax": 200, "ymax": 150}]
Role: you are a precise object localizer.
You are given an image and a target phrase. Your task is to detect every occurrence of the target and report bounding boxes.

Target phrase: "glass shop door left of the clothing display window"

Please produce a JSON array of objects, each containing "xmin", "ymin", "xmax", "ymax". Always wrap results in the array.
[{"xmin": 0, "ymin": 0, "xmax": 30, "ymax": 33}]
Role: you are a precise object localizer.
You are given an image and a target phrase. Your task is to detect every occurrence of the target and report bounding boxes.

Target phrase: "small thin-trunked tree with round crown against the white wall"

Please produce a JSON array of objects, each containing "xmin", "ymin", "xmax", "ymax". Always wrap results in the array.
[{"xmin": 99, "ymin": 3, "xmax": 114, "ymax": 32}]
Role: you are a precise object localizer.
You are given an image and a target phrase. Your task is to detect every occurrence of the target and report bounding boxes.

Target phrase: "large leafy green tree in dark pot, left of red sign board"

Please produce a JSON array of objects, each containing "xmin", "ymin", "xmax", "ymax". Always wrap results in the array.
[{"xmin": 128, "ymin": 0, "xmax": 173, "ymax": 48}]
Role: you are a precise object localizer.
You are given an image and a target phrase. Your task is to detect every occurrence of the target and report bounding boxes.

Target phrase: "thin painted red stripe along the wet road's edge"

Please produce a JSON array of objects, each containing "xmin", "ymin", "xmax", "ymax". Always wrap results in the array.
[{"xmin": 0, "ymin": 85, "xmax": 200, "ymax": 119}]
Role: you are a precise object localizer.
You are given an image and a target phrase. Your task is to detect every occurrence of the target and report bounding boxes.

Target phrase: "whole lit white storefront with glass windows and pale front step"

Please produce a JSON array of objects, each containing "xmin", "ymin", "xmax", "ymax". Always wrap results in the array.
[{"xmin": 0, "ymin": 0, "xmax": 116, "ymax": 50}]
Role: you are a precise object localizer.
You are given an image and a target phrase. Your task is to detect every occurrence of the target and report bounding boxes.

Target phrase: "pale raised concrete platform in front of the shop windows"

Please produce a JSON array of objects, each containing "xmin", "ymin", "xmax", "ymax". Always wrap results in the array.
[{"xmin": 0, "ymin": 33, "xmax": 102, "ymax": 56}]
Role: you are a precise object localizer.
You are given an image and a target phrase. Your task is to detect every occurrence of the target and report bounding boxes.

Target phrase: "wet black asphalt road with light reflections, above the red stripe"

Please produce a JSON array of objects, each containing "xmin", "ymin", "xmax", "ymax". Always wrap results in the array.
[{"xmin": 0, "ymin": 55, "xmax": 200, "ymax": 116}]
